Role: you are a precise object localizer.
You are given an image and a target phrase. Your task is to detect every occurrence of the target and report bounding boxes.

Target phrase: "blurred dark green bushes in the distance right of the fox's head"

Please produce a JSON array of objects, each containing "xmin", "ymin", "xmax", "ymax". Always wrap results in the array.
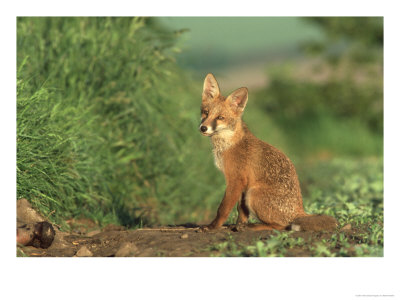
[{"xmin": 263, "ymin": 64, "xmax": 383, "ymax": 133}]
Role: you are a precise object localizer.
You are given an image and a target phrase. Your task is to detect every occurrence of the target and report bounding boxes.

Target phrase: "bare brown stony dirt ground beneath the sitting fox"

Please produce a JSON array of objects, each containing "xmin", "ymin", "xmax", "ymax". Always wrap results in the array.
[{"xmin": 17, "ymin": 199, "xmax": 357, "ymax": 257}]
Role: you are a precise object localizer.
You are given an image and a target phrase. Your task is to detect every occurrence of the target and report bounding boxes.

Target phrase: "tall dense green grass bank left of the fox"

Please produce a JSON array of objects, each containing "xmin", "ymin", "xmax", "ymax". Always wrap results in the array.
[{"xmin": 17, "ymin": 18, "xmax": 219, "ymax": 226}]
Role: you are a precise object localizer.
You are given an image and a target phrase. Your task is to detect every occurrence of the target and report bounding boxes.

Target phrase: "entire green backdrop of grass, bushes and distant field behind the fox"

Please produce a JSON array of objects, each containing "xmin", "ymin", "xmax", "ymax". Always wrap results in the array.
[{"xmin": 17, "ymin": 17, "xmax": 383, "ymax": 234}]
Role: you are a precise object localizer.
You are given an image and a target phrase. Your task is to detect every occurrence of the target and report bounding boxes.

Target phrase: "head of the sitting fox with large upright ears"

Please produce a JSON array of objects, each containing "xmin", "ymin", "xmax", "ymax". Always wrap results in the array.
[{"xmin": 199, "ymin": 74, "xmax": 248, "ymax": 136}]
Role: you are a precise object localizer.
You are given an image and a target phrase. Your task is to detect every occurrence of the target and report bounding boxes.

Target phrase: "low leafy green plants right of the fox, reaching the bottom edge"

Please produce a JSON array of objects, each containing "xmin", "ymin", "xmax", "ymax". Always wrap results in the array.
[{"xmin": 299, "ymin": 159, "xmax": 384, "ymax": 256}]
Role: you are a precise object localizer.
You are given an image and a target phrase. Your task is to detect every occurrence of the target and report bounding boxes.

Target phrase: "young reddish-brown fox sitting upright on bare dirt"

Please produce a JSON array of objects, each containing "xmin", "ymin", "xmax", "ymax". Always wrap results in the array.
[{"xmin": 199, "ymin": 74, "xmax": 337, "ymax": 230}]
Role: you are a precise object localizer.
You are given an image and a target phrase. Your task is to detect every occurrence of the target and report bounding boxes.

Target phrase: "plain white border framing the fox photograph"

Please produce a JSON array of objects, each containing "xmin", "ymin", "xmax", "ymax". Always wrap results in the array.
[{"xmin": 0, "ymin": 0, "xmax": 400, "ymax": 299}]
